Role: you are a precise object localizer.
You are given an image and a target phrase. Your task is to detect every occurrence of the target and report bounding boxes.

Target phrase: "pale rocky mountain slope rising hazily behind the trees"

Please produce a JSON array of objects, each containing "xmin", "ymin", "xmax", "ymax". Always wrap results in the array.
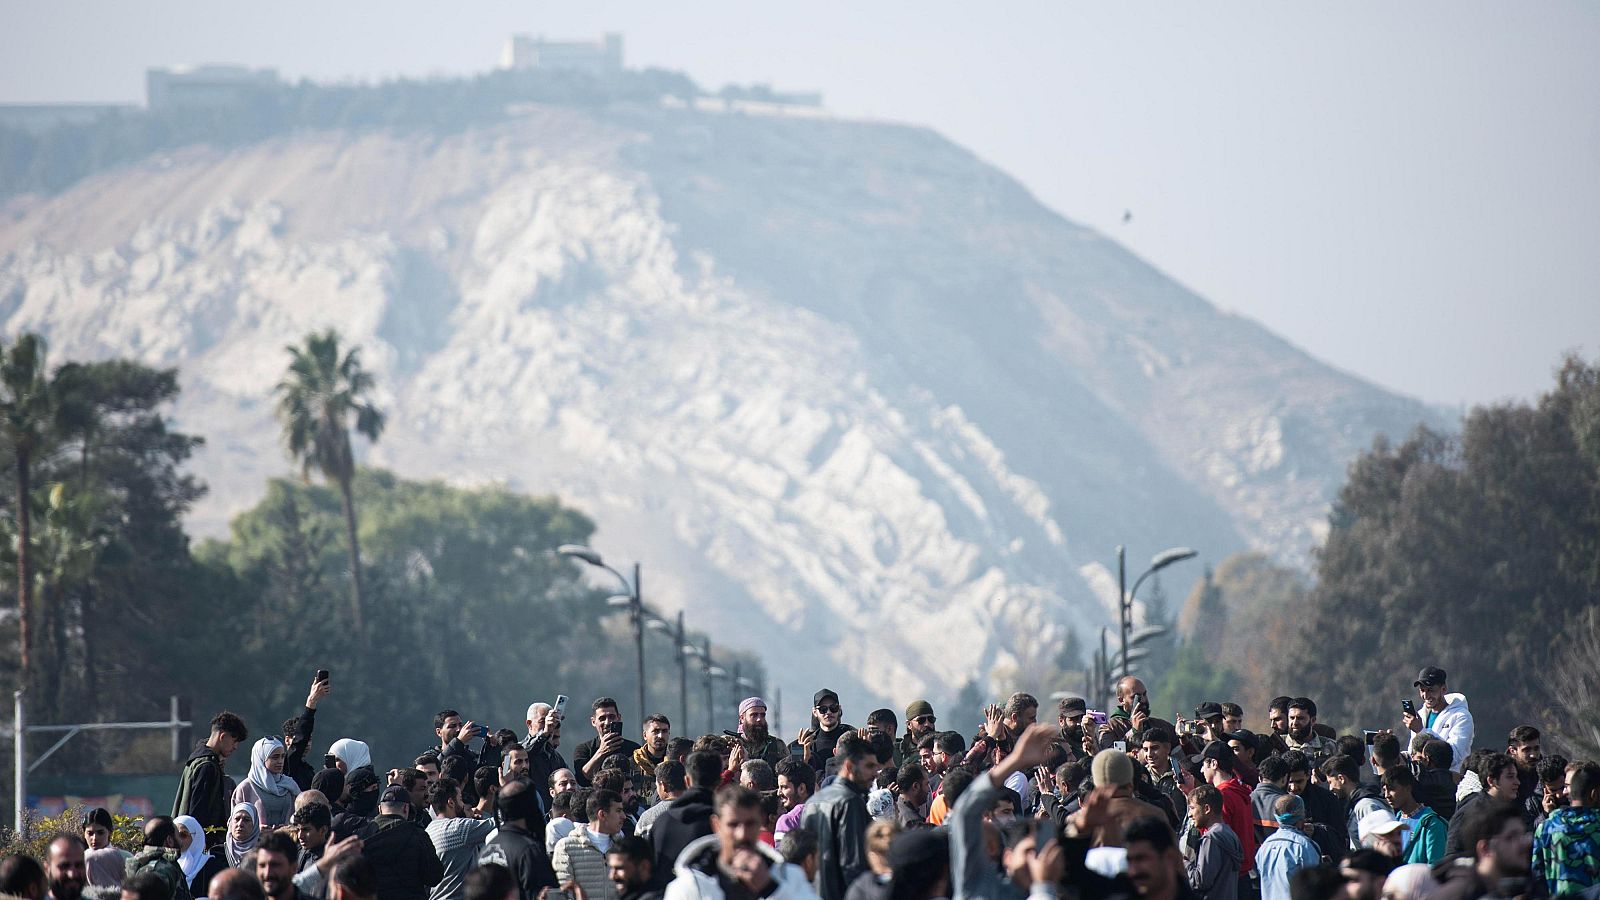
[{"xmin": 0, "ymin": 96, "xmax": 1442, "ymax": 714}]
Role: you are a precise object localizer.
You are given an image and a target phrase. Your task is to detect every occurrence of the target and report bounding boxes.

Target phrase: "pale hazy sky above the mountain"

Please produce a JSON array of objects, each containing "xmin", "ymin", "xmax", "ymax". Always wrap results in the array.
[{"xmin": 0, "ymin": 0, "xmax": 1600, "ymax": 404}]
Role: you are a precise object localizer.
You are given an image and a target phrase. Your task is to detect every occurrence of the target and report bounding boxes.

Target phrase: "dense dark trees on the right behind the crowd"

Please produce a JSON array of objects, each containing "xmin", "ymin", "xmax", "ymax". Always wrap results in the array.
[{"xmin": 1166, "ymin": 356, "xmax": 1600, "ymax": 757}]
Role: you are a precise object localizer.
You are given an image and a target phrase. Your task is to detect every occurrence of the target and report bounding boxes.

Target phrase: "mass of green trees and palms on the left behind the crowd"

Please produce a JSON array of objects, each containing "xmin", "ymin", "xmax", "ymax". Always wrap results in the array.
[{"xmin": 0, "ymin": 331, "xmax": 762, "ymax": 797}]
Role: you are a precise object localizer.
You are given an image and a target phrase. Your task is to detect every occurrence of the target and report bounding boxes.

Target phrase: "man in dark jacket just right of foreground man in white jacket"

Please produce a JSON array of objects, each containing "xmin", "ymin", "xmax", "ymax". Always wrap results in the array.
[{"xmin": 800, "ymin": 733, "xmax": 878, "ymax": 900}]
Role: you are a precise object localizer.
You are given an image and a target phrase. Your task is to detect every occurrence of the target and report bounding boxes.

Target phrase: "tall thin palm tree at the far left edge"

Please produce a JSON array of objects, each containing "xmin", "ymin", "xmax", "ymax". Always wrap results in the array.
[{"xmin": 0, "ymin": 335, "xmax": 54, "ymax": 690}]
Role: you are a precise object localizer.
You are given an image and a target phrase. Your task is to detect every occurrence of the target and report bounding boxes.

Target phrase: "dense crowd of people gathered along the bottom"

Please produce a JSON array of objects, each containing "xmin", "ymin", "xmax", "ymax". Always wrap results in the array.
[{"xmin": 0, "ymin": 666, "xmax": 1600, "ymax": 900}]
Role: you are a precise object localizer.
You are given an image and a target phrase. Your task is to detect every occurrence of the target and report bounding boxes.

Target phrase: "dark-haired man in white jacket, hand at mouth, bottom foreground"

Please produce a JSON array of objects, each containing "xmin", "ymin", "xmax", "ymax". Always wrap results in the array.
[{"xmin": 664, "ymin": 785, "xmax": 816, "ymax": 900}]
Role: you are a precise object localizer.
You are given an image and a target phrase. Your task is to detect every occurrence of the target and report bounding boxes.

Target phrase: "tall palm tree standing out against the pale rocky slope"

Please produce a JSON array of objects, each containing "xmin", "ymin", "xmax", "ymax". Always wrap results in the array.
[{"xmin": 277, "ymin": 328, "xmax": 384, "ymax": 641}]
